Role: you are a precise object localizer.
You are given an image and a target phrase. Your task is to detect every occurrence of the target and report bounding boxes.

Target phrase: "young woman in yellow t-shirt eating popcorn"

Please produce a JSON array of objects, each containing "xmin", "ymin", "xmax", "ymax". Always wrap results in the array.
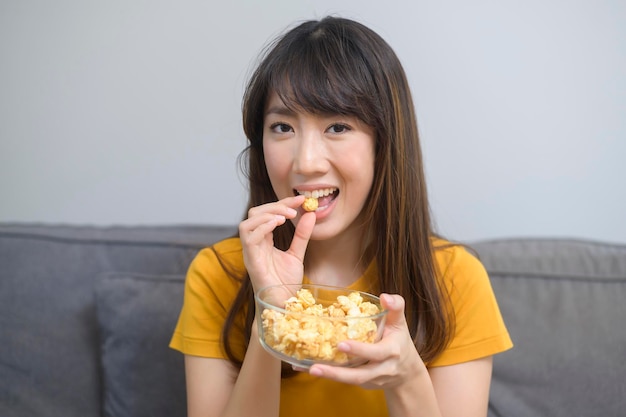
[{"xmin": 171, "ymin": 17, "xmax": 512, "ymax": 417}]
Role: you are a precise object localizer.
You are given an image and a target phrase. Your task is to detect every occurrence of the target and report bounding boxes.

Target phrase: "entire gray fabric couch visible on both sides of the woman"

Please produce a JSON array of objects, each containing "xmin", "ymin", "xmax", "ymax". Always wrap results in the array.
[{"xmin": 0, "ymin": 224, "xmax": 626, "ymax": 417}]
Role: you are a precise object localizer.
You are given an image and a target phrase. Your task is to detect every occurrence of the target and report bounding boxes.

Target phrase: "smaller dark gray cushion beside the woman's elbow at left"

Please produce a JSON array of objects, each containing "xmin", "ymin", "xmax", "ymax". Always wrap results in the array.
[{"xmin": 96, "ymin": 273, "xmax": 186, "ymax": 417}]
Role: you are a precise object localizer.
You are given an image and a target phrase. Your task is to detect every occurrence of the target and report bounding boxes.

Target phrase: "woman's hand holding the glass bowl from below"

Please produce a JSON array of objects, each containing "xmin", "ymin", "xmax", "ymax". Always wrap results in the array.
[{"xmin": 309, "ymin": 294, "xmax": 427, "ymax": 390}]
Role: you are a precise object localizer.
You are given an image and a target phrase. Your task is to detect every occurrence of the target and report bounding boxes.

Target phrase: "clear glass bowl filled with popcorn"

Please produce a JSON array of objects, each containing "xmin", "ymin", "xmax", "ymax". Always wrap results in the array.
[{"xmin": 255, "ymin": 284, "xmax": 387, "ymax": 369}]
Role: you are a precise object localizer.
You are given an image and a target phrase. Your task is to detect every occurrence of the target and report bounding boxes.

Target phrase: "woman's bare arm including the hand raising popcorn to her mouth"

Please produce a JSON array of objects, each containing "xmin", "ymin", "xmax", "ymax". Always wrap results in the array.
[{"xmin": 185, "ymin": 196, "xmax": 315, "ymax": 417}]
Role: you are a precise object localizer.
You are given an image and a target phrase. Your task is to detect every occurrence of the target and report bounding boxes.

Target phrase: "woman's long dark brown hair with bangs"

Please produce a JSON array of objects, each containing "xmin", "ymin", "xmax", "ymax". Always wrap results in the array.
[{"xmin": 222, "ymin": 17, "xmax": 454, "ymax": 366}]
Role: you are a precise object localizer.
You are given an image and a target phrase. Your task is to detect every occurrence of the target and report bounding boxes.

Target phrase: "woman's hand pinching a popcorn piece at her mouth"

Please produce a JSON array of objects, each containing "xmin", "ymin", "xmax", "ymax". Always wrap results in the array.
[{"xmin": 239, "ymin": 195, "xmax": 315, "ymax": 293}]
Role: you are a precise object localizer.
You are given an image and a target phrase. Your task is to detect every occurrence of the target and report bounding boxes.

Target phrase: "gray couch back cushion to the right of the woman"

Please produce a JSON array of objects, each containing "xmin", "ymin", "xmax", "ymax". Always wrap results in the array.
[{"xmin": 473, "ymin": 239, "xmax": 626, "ymax": 417}]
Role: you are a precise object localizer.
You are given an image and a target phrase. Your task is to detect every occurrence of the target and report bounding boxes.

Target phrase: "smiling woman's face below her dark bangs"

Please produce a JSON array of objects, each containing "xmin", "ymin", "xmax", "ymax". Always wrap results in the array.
[{"xmin": 263, "ymin": 93, "xmax": 375, "ymax": 240}]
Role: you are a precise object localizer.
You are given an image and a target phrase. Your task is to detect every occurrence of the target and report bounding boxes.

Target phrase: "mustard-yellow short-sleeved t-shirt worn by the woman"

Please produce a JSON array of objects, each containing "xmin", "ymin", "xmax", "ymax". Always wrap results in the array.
[{"xmin": 170, "ymin": 238, "xmax": 513, "ymax": 417}]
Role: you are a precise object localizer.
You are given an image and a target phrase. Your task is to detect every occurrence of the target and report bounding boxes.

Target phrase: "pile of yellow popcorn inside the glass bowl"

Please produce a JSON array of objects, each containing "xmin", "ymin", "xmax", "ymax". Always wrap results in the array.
[{"xmin": 261, "ymin": 289, "xmax": 380, "ymax": 363}]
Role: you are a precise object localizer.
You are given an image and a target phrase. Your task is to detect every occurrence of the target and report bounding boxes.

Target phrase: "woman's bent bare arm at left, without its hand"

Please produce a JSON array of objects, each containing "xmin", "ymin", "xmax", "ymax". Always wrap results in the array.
[{"xmin": 185, "ymin": 318, "xmax": 280, "ymax": 417}]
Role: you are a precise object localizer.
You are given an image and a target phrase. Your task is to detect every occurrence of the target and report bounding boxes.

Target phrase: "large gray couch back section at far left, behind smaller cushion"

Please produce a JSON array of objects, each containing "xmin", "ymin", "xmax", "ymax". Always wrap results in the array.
[{"xmin": 0, "ymin": 224, "xmax": 235, "ymax": 417}]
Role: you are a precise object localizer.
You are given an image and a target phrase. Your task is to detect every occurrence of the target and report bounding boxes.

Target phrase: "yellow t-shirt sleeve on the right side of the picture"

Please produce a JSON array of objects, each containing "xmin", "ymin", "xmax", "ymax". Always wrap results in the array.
[{"xmin": 428, "ymin": 246, "xmax": 513, "ymax": 367}]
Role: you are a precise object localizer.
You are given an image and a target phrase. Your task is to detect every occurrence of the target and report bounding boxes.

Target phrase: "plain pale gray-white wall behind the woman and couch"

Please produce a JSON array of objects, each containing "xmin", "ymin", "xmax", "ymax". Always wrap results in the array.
[{"xmin": 0, "ymin": 0, "xmax": 626, "ymax": 242}]
